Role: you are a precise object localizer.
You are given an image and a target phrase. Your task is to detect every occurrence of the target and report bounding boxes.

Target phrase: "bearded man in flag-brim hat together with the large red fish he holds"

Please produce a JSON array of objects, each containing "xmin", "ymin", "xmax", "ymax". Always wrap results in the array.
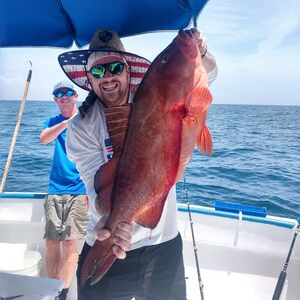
[{"xmin": 58, "ymin": 28, "xmax": 217, "ymax": 300}]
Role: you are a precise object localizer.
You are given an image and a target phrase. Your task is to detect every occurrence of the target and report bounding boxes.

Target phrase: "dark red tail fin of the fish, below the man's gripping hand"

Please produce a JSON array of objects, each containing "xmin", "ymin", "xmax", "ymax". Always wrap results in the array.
[{"xmin": 80, "ymin": 238, "xmax": 116, "ymax": 288}]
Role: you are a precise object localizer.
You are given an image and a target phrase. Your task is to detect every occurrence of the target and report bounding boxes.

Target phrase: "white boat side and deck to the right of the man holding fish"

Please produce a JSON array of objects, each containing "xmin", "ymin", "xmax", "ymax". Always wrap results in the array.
[{"xmin": 179, "ymin": 208, "xmax": 300, "ymax": 300}]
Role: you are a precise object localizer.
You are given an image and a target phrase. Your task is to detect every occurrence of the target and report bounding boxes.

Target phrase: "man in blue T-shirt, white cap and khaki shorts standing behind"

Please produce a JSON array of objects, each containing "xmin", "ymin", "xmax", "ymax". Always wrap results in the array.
[{"xmin": 40, "ymin": 82, "xmax": 89, "ymax": 300}]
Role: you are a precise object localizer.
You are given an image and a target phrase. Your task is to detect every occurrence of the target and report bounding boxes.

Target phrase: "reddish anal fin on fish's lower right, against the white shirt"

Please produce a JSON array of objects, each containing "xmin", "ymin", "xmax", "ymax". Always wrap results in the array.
[{"xmin": 134, "ymin": 197, "xmax": 166, "ymax": 229}]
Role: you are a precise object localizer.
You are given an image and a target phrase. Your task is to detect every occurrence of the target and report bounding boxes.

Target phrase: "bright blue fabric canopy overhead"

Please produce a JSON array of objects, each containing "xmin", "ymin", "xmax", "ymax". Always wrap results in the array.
[{"xmin": 0, "ymin": 0, "xmax": 208, "ymax": 48}]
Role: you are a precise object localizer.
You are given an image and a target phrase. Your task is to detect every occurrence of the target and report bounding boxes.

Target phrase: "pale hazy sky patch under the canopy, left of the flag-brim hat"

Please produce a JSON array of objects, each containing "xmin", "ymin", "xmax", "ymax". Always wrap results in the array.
[{"xmin": 0, "ymin": 48, "xmax": 86, "ymax": 100}]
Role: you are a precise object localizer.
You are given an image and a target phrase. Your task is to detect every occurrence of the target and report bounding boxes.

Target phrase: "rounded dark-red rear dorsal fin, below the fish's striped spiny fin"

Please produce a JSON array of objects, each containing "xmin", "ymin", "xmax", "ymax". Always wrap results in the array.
[{"xmin": 94, "ymin": 157, "xmax": 120, "ymax": 216}]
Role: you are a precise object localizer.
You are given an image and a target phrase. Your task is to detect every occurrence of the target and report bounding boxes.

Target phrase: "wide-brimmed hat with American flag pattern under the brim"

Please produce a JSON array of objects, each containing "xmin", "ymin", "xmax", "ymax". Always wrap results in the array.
[{"xmin": 58, "ymin": 29, "xmax": 150, "ymax": 91}]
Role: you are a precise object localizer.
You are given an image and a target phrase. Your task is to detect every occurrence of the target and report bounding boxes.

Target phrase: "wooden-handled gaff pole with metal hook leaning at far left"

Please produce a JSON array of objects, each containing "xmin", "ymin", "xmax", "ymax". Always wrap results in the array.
[{"xmin": 0, "ymin": 61, "xmax": 32, "ymax": 193}]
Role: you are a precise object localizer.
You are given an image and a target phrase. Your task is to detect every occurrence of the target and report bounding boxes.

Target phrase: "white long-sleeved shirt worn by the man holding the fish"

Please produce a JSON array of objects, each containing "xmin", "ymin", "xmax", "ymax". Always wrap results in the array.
[{"xmin": 66, "ymin": 63, "xmax": 217, "ymax": 249}]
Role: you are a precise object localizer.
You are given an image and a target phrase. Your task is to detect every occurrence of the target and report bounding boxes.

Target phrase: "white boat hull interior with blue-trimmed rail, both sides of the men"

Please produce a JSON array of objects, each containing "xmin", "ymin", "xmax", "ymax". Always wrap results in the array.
[{"xmin": 0, "ymin": 193, "xmax": 300, "ymax": 300}]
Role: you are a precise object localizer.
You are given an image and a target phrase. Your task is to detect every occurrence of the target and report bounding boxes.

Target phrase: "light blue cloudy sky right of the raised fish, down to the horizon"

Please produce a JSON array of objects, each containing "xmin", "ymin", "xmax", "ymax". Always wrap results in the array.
[{"xmin": 198, "ymin": 0, "xmax": 300, "ymax": 105}]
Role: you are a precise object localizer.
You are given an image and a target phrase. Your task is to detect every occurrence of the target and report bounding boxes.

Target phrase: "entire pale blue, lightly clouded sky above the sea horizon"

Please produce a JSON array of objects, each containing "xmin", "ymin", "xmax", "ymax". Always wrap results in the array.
[{"xmin": 0, "ymin": 0, "xmax": 300, "ymax": 105}]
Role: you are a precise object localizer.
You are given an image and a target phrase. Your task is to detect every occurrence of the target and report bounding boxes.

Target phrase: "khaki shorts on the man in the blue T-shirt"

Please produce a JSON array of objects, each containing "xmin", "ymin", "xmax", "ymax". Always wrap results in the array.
[{"xmin": 44, "ymin": 195, "xmax": 89, "ymax": 241}]
